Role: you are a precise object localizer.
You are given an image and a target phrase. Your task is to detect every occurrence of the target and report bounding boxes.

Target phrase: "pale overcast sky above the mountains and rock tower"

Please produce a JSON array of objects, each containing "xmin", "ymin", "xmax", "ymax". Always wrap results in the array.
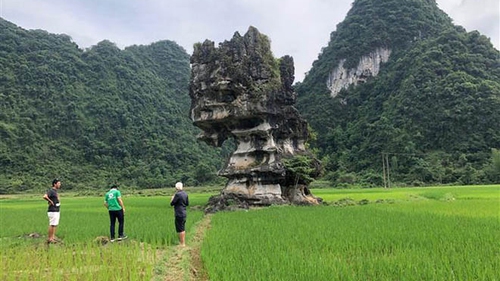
[{"xmin": 0, "ymin": 0, "xmax": 500, "ymax": 82}]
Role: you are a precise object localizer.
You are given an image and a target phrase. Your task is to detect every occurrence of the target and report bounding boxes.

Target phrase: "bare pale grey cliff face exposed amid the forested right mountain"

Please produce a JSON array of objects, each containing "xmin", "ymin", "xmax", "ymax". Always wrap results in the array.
[{"xmin": 327, "ymin": 48, "xmax": 391, "ymax": 97}]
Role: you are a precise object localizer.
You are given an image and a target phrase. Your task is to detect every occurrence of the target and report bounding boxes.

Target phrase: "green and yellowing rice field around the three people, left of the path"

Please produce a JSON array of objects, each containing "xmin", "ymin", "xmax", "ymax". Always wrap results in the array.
[{"xmin": 0, "ymin": 193, "xmax": 210, "ymax": 280}]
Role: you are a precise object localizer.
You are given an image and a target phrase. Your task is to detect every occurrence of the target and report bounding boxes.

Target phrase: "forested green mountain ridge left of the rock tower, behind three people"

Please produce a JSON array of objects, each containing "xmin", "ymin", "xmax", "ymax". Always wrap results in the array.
[{"xmin": 0, "ymin": 19, "xmax": 221, "ymax": 192}]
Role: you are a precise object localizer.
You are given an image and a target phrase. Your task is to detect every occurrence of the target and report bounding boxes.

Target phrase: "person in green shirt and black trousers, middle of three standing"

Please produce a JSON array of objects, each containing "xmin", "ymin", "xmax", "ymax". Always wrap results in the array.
[{"xmin": 104, "ymin": 184, "xmax": 127, "ymax": 242}]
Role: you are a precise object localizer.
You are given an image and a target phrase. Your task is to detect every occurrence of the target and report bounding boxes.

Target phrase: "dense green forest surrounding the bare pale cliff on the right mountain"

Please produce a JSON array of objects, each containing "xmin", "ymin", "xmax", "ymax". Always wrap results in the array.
[{"xmin": 297, "ymin": 0, "xmax": 500, "ymax": 186}]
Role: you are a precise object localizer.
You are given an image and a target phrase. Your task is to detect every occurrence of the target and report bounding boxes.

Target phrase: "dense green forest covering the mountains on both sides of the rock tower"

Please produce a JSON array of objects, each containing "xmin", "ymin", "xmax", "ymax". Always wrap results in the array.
[{"xmin": 0, "ymin": 0, "xmax": 500, "ymax": 193}]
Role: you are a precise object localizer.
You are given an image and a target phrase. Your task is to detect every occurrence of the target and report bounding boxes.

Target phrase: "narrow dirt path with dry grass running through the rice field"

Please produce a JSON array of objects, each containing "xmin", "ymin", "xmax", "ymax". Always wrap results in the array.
[{"xmin": 162, "ymin": 215, "xmax": 211, "ymax": 281}]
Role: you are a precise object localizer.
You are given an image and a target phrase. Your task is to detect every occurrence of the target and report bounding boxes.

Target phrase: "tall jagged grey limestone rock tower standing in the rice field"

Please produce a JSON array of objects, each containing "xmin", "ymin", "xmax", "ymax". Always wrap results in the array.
[{"xmin": 189, "ymin": 27, "xmax": 321, "ymax": 205}]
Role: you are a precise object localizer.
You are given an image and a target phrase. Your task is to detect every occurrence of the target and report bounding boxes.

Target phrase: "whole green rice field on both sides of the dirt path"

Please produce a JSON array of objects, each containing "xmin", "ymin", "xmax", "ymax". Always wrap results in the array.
[{"xmin": 0, "ymin": 186, "xmax": 500, "ymax": 280}]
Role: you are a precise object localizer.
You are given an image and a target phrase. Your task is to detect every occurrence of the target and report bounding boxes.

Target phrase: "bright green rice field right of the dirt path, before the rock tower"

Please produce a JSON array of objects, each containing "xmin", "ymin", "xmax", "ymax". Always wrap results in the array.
[{"xmin": 202, "ymin": 186, "xmax": 500, "ymax": 280}]
